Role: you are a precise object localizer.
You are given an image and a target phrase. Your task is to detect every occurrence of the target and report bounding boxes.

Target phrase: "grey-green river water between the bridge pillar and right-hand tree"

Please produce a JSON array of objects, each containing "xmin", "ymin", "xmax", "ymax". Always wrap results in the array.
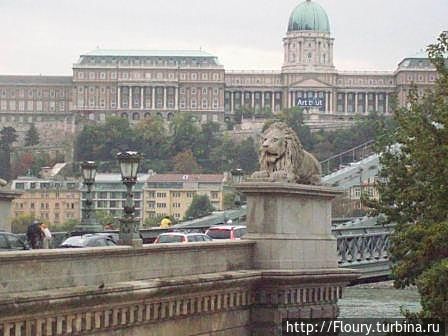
[{"xmin": 339, "ymin": 282, "xmax": 420, "ymax": 318}]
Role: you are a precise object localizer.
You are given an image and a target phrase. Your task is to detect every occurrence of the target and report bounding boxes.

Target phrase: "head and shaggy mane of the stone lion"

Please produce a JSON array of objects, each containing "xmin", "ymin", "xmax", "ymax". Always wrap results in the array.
[{"xmin": 260, "ymin": 122, "xmax": 303, "ymax": 171}]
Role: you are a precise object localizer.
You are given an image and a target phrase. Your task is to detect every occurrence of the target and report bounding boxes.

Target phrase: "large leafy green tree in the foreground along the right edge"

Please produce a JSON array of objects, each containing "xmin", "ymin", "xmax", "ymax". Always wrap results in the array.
[{"xmin": 376, "ymin": 32, "xmax": 448, "ymax": 319}]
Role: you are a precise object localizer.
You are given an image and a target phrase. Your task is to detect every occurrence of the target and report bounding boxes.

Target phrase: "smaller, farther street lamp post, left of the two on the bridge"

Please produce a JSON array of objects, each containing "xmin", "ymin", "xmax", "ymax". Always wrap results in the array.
[{"xmin": 75, "ymin": 161, "xmax": 103, "ymax": 233}]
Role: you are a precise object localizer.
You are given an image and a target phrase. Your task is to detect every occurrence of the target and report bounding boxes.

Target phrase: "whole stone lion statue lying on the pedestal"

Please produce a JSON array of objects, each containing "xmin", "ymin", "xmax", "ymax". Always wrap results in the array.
[{"xmin": 252, "ymin": 122, "xmax": 321, "ymax": 184}]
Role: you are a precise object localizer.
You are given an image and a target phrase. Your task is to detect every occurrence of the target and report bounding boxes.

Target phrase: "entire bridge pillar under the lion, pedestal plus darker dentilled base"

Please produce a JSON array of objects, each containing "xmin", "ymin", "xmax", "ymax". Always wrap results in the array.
[{"xmin": 237, "ymin": 180, "xmax": 358, "ymax": 336}]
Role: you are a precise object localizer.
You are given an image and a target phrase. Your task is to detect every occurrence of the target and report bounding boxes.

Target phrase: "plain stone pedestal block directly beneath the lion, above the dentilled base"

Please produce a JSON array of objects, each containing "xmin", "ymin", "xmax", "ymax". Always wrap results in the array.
[{"xmin": 237, "ymin": 181, "xmax": 342, "ymax": 270}]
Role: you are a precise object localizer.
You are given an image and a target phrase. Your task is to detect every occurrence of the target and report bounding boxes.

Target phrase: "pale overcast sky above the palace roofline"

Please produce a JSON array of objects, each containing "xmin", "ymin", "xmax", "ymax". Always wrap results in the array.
[{"xmin": 0, "ymin": 0, "xmax": 448, "ymax": 75}]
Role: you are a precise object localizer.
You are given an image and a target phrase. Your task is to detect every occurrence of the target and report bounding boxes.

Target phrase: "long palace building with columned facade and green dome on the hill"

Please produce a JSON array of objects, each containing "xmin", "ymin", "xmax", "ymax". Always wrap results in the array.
[{"xmin": 0, "ymin": 0, "xmax": 436, "ymax": 148}]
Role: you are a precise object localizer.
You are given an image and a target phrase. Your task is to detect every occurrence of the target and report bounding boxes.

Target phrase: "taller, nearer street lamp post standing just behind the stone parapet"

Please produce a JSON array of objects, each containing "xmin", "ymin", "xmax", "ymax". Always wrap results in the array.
[{"xmin": 117, "ymin": 152, "xmax": 143, "ymax": 247}]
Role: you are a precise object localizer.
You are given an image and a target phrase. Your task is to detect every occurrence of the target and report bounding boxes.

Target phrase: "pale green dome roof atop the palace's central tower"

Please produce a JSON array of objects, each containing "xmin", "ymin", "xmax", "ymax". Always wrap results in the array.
[{"xmin": 288, "ymin": 0, "xmax": 330, "ymax": 33}]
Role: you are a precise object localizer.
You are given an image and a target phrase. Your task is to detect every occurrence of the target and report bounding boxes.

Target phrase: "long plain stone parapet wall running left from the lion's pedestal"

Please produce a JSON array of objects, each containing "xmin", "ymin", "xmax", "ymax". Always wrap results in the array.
[{"xmin": 0, "ymin": 241, "xmax": 254, "ymax": 297}]
